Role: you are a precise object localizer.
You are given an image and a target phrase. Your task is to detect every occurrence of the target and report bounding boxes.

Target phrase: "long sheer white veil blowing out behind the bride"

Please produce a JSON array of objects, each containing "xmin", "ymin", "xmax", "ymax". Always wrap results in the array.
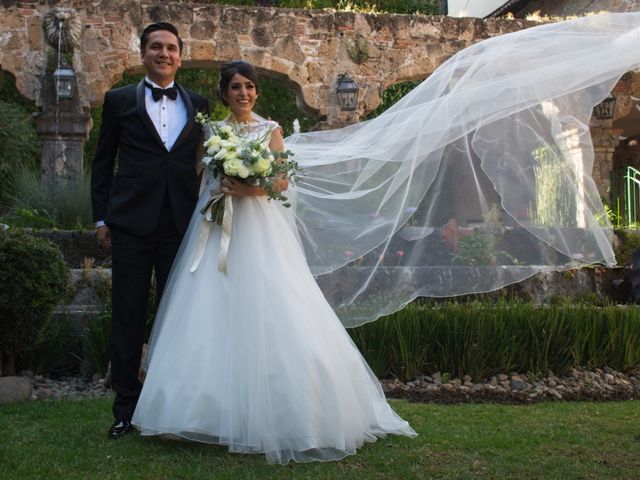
[{"xmin": 285, "ymin": 13, "xmax": 640, "ymax": 326}]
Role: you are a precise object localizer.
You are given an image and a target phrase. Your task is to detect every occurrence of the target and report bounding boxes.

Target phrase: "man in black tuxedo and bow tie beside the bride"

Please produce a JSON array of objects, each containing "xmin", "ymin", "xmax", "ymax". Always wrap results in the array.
[{"xmin": 91, "ymin": 23, "xmax": 209, "ymax": 439}]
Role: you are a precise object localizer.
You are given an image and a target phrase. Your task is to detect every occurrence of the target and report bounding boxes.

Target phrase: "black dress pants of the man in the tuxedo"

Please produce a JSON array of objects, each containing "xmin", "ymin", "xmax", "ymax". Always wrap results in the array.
[{"xmin": 111, "ymin": 199, "xmax": 182, "ymax": 420}]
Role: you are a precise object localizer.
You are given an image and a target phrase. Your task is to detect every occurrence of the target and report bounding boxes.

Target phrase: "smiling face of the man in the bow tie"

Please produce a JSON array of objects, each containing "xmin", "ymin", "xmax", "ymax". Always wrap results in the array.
[{"xmin": 141, "ymin": 30, "xmax": 182, "ymax": 87}]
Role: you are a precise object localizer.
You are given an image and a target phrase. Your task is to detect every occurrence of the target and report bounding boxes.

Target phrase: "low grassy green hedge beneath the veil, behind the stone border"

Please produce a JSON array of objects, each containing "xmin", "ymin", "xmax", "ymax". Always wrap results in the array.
[{"xmin": 349, "ymin": 302, "xmax": 640, "ymax": 381}]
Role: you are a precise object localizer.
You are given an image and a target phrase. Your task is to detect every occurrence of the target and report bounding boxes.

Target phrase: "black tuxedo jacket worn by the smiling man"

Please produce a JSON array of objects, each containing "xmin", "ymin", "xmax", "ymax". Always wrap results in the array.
[{"xmin": 91, "ymin": 82, "xmax": 209, "ymax": 235}]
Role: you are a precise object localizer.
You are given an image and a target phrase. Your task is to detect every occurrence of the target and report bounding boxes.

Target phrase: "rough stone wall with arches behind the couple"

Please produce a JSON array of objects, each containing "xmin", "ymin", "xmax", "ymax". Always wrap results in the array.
[{"xmin": 0, "ymin": 0, "xmax": 529, "ymax": 127}]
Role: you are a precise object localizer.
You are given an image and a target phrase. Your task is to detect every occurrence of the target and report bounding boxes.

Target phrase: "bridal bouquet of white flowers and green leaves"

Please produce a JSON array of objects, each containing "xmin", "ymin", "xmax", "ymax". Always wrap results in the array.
[{"xmin": 196, "ymin": 113, "xmax": 300, "ymax": 225}]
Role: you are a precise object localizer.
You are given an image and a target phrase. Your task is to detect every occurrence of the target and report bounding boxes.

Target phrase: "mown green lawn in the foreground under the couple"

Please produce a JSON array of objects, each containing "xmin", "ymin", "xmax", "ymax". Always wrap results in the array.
[{"xmin": 0, "ymin": 398, "xmax": 640, "ymax": 480}]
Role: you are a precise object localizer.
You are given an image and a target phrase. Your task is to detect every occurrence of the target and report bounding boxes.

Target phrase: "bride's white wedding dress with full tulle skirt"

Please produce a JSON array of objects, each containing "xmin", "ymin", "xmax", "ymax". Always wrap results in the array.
[{"xmin": 132, "ymin": 121, "xmax": 416, "ymax": 463}]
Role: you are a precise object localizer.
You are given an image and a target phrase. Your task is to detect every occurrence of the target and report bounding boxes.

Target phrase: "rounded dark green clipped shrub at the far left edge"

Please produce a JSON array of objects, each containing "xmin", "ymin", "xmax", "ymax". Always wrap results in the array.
[{"xmin": 0, "ymin": 230, "xmax": 69, "ymax": 375}]
